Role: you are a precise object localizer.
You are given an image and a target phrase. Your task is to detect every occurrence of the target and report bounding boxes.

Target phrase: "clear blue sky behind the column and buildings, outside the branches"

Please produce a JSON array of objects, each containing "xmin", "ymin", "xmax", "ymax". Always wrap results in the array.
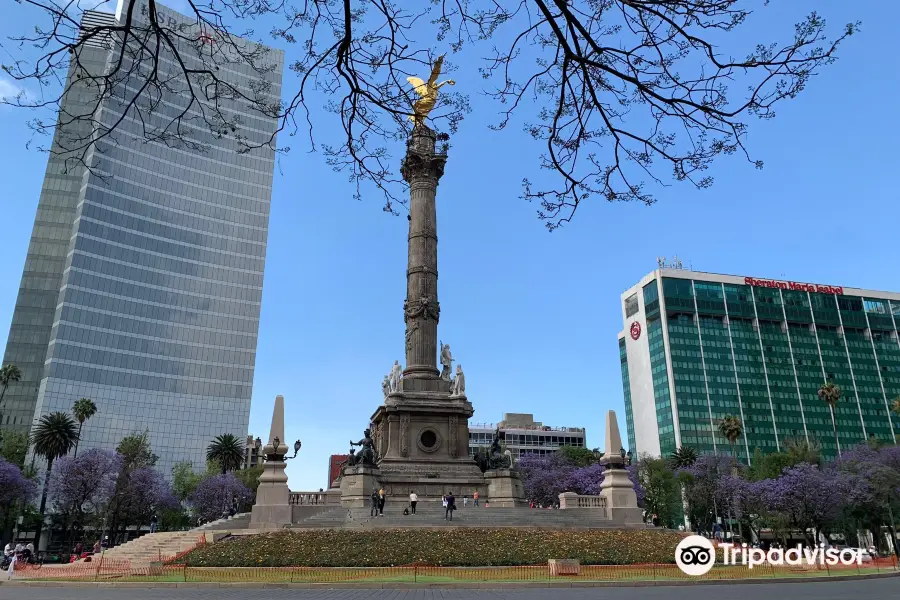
[{"xmin": 0, "ymin": 0, "xmax": 900, "ymax": 490}]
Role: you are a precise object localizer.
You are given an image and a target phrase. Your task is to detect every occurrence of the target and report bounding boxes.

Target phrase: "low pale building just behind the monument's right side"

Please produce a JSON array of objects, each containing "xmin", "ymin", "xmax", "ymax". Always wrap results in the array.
[{"xmin": 469, "ymin": 413, "xmax": 587, "ymax": 459}]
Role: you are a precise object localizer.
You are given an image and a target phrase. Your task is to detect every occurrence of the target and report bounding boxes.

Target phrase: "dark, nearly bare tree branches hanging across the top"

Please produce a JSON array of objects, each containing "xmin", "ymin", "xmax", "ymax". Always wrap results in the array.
[{"xmin": 3, "ymin": 0, "xmax": 859, "ymax": 230}]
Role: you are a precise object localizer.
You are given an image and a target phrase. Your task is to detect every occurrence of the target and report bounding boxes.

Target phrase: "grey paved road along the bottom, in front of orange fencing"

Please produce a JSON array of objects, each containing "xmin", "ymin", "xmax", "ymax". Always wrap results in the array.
[{"xmin": 0, "ymin": 577, "xmax": 900, "ymax": 600}]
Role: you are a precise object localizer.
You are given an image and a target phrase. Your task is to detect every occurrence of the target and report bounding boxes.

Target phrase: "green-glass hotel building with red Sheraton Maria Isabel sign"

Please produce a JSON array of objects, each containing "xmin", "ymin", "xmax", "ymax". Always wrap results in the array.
[{"xmin": 618, "ymin": 269, "xmax": 900, "ymax": 462}]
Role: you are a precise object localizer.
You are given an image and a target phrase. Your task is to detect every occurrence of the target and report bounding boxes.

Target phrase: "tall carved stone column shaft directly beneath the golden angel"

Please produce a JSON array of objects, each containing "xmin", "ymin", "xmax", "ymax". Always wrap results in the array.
[{"xmin": 400, "ymin": 124, "xmax": 447, "ymax": 379}]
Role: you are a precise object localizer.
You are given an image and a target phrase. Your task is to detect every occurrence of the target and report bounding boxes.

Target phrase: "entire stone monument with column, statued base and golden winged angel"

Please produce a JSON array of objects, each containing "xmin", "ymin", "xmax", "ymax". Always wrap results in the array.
[{"xmin": 340, "ymin": 56, "xmax": 525, "ymax": 506}]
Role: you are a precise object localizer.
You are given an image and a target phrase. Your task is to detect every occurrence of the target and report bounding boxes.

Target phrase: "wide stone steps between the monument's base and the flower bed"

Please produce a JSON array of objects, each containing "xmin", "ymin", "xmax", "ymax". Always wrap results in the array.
[{"xmin": 292, "ymin": 502, "xmax": 640, "ymax": 529}]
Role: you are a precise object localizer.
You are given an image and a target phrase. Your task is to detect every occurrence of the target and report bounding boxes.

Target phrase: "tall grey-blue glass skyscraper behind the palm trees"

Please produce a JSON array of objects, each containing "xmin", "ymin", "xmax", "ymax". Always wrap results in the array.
[{"xmin": 3, "ymin": 4, "xmax": 283, "ymax": 473}]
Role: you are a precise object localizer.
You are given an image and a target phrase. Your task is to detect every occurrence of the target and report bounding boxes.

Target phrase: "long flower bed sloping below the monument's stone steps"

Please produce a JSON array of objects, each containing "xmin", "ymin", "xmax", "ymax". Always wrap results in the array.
[{"xmin": 178, "ymin": 528, "xmax": 682, "ymax": 567}]
